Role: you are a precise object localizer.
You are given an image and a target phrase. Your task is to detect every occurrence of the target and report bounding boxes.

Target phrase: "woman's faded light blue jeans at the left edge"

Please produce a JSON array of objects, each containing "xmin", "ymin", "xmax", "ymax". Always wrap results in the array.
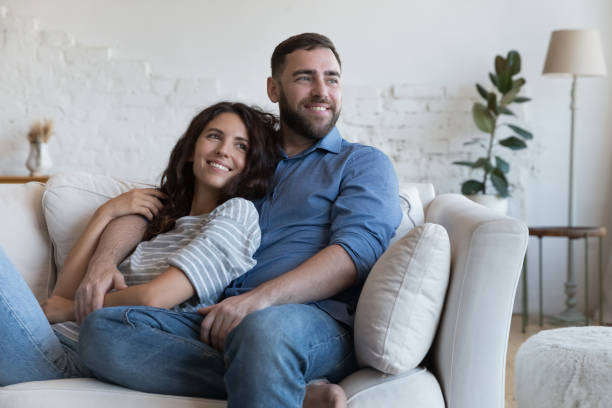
[{"xmin": 0, "ymin": 248, "xmax": 90, "ymax": 386}]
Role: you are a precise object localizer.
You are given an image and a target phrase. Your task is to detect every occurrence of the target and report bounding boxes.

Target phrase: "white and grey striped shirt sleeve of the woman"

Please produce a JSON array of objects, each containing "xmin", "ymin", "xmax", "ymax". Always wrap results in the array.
[{"xmin": 168, "ymin": 198, "xmax": 261, "ymax": 305}]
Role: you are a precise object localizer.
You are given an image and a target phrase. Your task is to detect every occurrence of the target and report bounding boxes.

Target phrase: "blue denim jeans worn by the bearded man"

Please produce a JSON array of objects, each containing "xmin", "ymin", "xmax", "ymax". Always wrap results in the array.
[{"xmin": 79, "ymin": 304, "xmax": 356, "ymax": 408}]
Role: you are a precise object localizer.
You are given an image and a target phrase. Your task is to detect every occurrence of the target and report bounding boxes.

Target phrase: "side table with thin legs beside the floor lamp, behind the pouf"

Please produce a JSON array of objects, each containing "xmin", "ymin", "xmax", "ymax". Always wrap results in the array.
[{"xmin": 522, "ymin": 227, "xmax": 607, "ymax": 333}]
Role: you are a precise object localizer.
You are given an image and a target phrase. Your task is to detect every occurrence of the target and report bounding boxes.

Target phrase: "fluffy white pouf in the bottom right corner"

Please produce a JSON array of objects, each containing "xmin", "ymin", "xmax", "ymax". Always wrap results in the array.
[{"xmin": 514, "ymin": 326, "xmax": 612, "ymax": 408}]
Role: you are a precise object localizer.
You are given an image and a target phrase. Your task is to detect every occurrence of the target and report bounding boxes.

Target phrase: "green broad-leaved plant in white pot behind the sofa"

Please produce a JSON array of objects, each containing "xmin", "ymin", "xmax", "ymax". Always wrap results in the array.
[{"xmin": 453, "ymin": 51, "xmax": 533, "ymax": 213}]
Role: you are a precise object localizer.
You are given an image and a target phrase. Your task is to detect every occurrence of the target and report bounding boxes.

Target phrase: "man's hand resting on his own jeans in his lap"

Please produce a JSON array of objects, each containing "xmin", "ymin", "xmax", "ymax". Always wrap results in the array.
[{"xmin": 198, "ymin": 290, "xmax": 271, "ymax": 351}]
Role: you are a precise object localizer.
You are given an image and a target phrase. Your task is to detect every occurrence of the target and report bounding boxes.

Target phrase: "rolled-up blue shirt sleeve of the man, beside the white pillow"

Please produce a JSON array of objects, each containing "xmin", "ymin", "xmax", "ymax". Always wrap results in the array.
[{"xmin": 330, "ymin": 146, "xmax": 402, "ymax": 285}]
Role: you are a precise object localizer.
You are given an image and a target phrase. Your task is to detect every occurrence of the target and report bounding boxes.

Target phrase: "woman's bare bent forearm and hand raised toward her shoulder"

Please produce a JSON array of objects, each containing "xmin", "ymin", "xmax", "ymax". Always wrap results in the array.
[{"xmin": 53, "ymin": 188, "xmax": 165, "ymax": 299}]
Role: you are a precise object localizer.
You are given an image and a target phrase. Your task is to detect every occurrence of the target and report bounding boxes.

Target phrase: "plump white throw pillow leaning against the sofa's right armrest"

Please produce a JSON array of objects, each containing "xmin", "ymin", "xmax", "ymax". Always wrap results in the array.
[{"xmin": 355, "ymin": 223, "xmax": 450, "ymax": 374}]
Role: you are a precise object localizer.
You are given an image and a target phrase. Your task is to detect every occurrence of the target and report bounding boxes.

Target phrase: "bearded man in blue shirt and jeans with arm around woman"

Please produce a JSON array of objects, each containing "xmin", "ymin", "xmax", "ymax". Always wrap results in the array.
[{"xmin": 76, "ymin": 33, "xmax": 401, "ymax": 408}]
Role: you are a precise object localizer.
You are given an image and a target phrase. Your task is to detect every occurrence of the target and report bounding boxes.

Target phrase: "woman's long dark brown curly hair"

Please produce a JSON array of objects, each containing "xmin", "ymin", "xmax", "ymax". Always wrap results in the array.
[{"xmin": 144, "ymin": 102, "xmax": 281, "ymax": 240}]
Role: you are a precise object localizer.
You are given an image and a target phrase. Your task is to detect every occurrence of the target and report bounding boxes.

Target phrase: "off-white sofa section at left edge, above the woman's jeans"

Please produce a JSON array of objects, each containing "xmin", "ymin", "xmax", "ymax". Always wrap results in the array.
[{"xmin": 0, "ymin": 183, "xmax": 54, "ymax": 301}]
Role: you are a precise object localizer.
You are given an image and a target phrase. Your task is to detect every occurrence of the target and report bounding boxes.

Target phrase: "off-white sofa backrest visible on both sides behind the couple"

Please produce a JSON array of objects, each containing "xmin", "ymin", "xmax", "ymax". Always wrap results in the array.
[{"xmin": 0, "ymin": 172, "xmax": 435, "ymax": 300}]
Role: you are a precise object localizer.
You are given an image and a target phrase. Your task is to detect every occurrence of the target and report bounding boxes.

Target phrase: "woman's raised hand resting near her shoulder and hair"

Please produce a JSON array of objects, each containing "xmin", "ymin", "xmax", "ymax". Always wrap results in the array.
[{"xmin": 98, "ymin": 188, "xmax": 166, "ymax": 221}]
